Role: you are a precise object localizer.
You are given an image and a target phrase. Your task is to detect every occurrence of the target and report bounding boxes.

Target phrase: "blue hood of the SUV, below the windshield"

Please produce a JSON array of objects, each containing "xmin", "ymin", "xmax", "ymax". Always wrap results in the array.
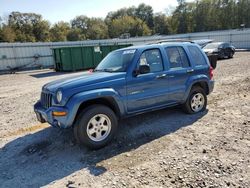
[{"xmin": 43, "ymin": 72, "xmax": 126, "ymax": 93}]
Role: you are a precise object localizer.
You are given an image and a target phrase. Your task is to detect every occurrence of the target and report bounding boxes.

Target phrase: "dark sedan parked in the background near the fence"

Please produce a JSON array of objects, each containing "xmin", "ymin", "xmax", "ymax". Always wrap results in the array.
[{"xmin": 203, "ymin": 42, "xmax": 235, "ymax": 59}]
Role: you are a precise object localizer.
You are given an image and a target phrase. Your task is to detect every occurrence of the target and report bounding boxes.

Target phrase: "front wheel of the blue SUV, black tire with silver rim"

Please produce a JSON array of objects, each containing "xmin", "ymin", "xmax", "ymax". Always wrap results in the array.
[{"xmin": 74, "ymin": 105, "xmax": 118, "ymax": 149}]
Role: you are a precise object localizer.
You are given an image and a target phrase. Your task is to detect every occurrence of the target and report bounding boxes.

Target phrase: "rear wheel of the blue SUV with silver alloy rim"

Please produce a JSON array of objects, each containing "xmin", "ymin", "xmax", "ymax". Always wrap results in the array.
[{"xmin": 183, "ymin": 86, "xmax": 207, "ymax": 114}]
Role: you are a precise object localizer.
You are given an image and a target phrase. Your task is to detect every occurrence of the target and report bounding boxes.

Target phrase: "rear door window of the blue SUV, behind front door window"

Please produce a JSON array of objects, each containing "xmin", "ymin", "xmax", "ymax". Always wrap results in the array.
[{"xmin": 166, "ymin": 47, "xmax": 190, "ymax": 68}]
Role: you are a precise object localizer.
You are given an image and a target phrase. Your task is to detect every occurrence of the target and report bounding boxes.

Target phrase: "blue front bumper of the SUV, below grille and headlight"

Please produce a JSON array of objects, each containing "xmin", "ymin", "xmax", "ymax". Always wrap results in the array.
[{"xmin": 34, "ymin": 101, "xmax": 71, "ymax": 128}]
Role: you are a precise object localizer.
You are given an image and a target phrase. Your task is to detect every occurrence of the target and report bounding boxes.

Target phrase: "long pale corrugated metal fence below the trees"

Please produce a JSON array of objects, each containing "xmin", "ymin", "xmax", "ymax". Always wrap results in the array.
[{"xmin": 0, "ymin": 28, "xmax": 250, "ymax": 71}]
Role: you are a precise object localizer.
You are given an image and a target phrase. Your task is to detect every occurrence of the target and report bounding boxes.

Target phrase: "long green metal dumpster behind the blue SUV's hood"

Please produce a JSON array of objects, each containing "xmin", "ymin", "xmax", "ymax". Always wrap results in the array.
[{"xmin": 52, "ymin": 44, "xmax": 131, "ymax": 71}]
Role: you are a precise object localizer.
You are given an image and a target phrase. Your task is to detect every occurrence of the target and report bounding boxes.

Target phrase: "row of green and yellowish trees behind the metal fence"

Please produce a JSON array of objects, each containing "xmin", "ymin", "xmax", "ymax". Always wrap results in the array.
[{"xmin": 0, "ymin": 0, "xmax": 250, "ymax": 42}]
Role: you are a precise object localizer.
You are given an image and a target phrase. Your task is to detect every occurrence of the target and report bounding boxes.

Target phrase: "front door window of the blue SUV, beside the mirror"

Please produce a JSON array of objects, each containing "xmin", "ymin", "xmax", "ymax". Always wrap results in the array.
[{"xmin": 139, "ymin": 49, "xmax": 163, "ymax": 72}]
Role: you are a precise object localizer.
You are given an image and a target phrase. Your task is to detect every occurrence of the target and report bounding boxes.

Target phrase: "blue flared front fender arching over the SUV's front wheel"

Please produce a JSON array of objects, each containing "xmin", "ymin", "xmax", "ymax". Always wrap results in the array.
[{"xmin": 65, "ymin": 88, "xmax": 125, "ymax": 126}]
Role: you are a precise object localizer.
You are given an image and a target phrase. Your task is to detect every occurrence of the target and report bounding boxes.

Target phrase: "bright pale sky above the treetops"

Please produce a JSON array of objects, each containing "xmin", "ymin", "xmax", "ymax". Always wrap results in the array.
[{"xmin": 0, "ymin": 0, "xmax": 191, "ymax": 23}]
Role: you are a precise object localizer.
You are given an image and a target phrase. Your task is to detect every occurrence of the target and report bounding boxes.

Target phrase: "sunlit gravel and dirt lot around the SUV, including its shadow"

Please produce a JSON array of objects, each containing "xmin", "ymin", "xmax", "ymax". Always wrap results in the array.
[{"xmin": 0, "ymin": 52, "xmax": 250, "ymax": 188}]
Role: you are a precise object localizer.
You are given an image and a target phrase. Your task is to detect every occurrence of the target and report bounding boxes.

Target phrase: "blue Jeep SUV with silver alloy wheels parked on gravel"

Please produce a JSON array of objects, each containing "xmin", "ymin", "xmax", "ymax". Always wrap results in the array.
[{"xmin": 34, "ymin": 42, "xmax": 214, "ymax": 149}]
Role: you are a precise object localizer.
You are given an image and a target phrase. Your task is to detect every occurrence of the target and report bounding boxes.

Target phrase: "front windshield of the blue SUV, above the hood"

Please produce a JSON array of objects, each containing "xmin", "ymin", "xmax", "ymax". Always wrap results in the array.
[{"xmin": 95, "ymin": 50, "xmax": 136, "ymax": 72}]
